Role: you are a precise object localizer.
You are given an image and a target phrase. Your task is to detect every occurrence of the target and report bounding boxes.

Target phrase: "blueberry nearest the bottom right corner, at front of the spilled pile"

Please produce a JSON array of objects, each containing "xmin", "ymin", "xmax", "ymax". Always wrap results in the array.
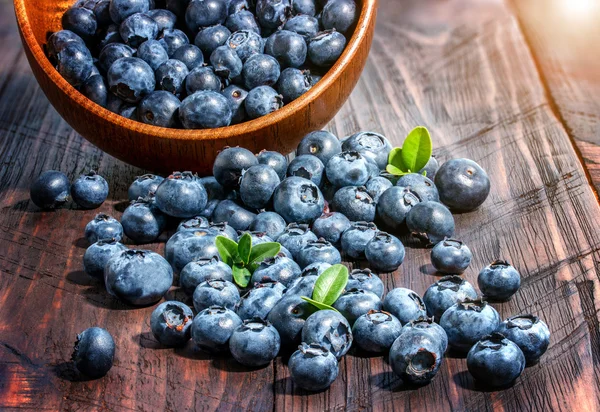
[{"xmin": 467, "ymin": 333, "xmax": 525, "ymax": 387}]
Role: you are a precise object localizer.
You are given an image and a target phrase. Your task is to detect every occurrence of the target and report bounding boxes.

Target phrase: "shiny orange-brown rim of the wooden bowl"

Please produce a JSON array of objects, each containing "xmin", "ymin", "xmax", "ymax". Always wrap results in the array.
[{"xmin": 13, "ymin": 0, "xmax": 378, "ymax": 141}]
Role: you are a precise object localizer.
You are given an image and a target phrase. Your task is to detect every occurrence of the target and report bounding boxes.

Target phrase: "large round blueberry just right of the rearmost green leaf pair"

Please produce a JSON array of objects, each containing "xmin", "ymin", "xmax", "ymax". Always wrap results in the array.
[{"xmin": 435, "ymin": 159, "xmax": 490, "ymax": 211}]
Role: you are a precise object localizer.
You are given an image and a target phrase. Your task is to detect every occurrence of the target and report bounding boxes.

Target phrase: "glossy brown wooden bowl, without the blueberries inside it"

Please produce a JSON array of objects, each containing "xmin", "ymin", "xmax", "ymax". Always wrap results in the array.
[{"xmin": 14, "ymin": 0, "xmax": 377, "ymax": 175}]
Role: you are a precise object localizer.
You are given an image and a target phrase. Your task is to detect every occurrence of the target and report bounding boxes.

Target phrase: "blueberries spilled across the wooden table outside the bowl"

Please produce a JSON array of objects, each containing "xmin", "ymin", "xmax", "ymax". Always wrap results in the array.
[{"xmin": 31, "ymin": 131, "xmax": 550, "ymax": 390}]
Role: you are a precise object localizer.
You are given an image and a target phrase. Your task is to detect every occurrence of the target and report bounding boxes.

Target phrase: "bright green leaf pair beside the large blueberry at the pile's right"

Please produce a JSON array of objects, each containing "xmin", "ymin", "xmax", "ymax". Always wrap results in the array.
[{"xmin": 385, "ymin": 126, "xmax": 432, "ymax": 176}]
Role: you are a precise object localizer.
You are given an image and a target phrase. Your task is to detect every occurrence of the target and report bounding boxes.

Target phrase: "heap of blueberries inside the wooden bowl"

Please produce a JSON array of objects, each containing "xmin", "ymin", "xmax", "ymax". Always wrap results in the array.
[{"xmin": 46, "ymin": 0, "xmax": 358, "ymax": 129}]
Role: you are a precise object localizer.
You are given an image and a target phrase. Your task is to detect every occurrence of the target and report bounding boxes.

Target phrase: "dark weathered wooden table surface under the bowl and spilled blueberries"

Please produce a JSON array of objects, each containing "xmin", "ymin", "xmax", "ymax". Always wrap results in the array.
[{"xmin": 0, "ymin": 0, "xmax": 600, "ymax": 412}]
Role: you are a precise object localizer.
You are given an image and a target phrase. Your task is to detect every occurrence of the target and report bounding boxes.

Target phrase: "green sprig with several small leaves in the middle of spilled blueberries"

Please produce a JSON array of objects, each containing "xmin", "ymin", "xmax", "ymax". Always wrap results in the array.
[{"xmin": 215, "ymin": 233, "xmax": 281, "ymax": 288}]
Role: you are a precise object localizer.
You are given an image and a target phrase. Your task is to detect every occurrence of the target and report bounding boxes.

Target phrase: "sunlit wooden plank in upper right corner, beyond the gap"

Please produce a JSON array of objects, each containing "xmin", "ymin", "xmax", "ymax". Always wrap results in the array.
[{"xmin": 511, "ymin": 0, "xmax": 600, "ymax": 196}]
